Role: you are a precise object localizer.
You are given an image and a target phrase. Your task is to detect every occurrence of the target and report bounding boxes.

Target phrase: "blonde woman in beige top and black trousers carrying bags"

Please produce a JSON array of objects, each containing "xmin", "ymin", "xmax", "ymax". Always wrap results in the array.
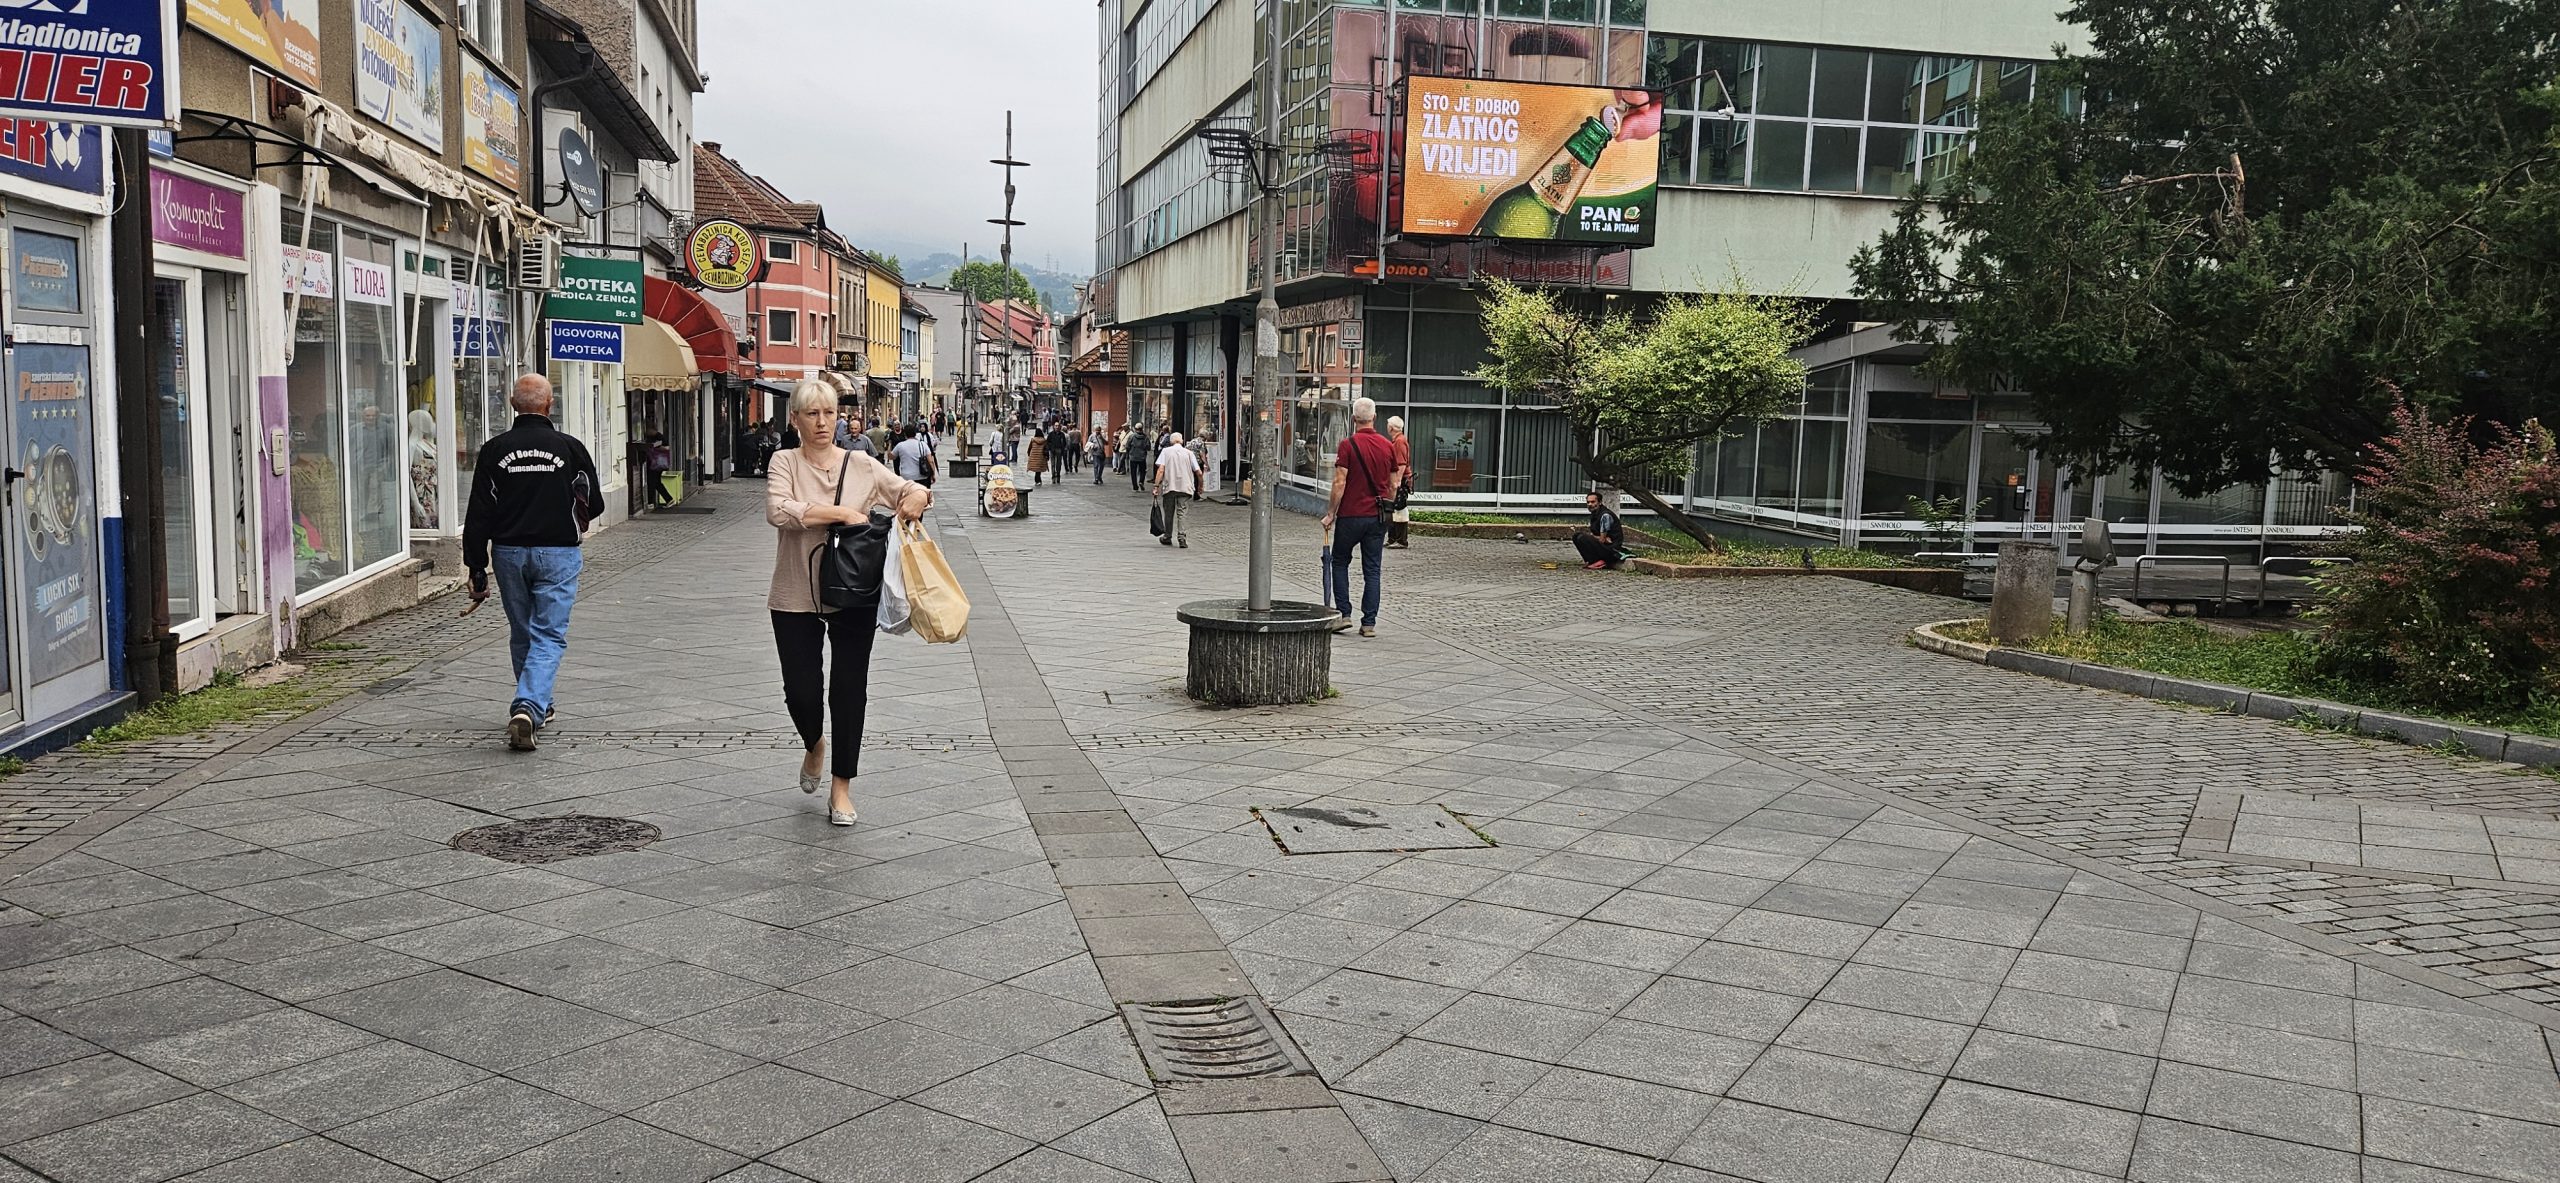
[{"xmin": 765, "ymin": 379, "xmax": 934, "ymax": 825}]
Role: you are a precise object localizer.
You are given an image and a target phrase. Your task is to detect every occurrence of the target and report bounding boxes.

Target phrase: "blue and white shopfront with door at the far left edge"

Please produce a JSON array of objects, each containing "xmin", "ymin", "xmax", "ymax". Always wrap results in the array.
[{"xmin": 0, "ymin": 123, "xmax": 123, "ymax": 737}]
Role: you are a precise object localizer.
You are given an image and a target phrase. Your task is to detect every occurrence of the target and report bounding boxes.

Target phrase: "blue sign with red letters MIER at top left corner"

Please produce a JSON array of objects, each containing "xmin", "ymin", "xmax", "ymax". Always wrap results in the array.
[{"xmin": 0, "ymin": 0, "xmax": 177, "ymax": 128}]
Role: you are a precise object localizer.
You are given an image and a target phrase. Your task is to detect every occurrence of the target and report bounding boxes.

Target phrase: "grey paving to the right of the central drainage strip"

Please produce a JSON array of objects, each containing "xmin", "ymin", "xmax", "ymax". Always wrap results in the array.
[{"xmin": 975, "ymin": 478, "xmax": 2560, "ymax": 1183}]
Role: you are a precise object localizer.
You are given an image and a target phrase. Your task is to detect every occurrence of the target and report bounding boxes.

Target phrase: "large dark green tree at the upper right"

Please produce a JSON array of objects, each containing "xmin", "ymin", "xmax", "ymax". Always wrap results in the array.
[{"xmin": 1853, "ymin": 0, "xmax": 2560, "ymax": 492}]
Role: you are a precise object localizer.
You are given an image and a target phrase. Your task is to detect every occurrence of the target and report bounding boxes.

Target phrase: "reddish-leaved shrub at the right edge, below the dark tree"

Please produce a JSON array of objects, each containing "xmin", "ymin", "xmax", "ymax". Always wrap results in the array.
[{"xmin": 2314, "ymin": 405, "xmax": 2560, "ymax": 712}]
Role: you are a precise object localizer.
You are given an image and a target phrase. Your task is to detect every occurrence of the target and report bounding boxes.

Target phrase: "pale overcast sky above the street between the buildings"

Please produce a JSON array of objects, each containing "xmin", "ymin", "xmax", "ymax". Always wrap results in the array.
[{"xmin": 694, "ymin": 0, "xmax": 1098, "ymax": 274}]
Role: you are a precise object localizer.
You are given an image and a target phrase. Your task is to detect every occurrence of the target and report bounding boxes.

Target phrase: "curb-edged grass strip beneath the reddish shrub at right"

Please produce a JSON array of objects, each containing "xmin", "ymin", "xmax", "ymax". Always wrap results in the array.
[{"xmin": 1938, "ymin": 615, "xmax": 2560, "ymax": 737}]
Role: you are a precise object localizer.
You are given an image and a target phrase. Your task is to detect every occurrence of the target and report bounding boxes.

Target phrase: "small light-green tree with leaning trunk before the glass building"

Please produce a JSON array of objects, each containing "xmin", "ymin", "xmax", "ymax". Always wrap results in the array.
[{"xmin": 1475, "ymin": 282, "xmax": 1815, "ymax": 551}]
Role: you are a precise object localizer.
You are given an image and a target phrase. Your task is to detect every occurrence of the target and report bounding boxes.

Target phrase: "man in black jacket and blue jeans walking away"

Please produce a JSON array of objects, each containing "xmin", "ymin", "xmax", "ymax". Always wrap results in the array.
[{"xmin": 463, "ymin": 374, "xmax": 604, "ymax": 753}]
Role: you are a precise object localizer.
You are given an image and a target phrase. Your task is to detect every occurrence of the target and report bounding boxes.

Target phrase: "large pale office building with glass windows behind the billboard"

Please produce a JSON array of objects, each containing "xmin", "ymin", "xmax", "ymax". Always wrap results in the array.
[{"xmin": 1093, "ymin": 0, "xmax": 2350, "ymax": 553}]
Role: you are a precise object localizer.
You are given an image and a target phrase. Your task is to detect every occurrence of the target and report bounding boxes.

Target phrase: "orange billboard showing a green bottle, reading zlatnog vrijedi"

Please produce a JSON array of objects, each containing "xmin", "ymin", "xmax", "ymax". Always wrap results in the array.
[{"xmin": 1398, "ymin": 77, "xmax": 1661, "ymax": 246}]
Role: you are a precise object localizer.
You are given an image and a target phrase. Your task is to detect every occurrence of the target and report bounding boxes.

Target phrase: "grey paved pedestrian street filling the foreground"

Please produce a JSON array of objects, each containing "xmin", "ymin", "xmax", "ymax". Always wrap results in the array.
[{"xmin": 0, "ymin": 481, "xmax": 2560, "ymax": 1183}]
